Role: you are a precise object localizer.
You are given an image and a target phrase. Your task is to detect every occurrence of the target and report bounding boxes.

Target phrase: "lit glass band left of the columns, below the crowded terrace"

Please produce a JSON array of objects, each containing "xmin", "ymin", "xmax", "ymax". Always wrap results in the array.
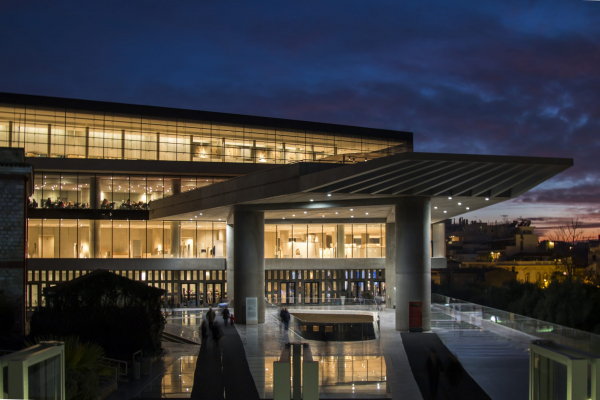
[{"xmin": 27, "ymin": 218, "xmax": 227, "ymax": 258}]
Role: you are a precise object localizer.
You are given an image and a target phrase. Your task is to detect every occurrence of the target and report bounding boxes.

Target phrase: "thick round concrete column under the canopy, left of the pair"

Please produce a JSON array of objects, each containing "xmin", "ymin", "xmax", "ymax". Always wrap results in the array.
[{"xmin": 233, "ymin": 210, "xmax": 265, "ymax": 324}]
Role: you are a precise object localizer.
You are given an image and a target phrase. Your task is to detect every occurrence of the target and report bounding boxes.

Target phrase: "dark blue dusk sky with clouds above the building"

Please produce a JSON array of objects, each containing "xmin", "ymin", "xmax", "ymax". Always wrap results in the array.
[{"xmin": 0, "ymin": 0, "xmax": 600, "ymax": 235}]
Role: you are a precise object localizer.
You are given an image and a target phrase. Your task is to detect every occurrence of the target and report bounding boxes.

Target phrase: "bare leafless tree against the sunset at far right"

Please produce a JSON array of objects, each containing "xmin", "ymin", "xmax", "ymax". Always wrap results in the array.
[{"xmin": 550, "ymin": 217, "xmax": 585, "ymax": 280}]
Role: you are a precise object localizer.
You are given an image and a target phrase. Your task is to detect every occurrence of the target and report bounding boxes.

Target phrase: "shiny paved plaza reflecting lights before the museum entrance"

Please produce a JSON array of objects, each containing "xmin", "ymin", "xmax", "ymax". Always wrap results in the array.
[{"xmin": 105, "ymin": 306, "xmax": 531, "ymax": 400}]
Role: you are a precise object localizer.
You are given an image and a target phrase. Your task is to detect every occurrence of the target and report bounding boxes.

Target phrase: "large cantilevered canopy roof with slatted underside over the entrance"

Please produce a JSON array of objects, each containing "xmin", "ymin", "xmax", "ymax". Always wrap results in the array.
[{"xmin": 150, "ymin": 153, "xmax": 573, "ymax": 223}]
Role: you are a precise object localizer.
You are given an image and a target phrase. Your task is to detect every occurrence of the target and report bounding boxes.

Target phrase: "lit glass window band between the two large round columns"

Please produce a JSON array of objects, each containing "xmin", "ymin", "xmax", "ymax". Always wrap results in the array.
[{"xmin": 265, "ymin": 224, "xmax": 385, "ymax": 258}]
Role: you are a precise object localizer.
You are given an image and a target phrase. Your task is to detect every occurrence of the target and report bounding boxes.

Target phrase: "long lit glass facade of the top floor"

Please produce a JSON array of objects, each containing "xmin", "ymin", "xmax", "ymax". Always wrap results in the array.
[{"xmin": 0, "ymin": 104, "xmax": 412, "ymax": 164}]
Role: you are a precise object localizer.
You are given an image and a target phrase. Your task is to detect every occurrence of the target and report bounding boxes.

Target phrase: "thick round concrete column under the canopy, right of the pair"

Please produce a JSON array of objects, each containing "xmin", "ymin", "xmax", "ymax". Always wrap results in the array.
[{"xmin": 395, "ymin": 196, "xmax": 431, "ymax": 331}]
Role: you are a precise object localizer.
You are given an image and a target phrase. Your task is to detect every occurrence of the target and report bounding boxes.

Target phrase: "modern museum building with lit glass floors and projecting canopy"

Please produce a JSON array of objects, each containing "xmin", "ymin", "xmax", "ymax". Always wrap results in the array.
[{"xmin": 0, "ymin": 93, "xmax": 573, "ymax": 330}]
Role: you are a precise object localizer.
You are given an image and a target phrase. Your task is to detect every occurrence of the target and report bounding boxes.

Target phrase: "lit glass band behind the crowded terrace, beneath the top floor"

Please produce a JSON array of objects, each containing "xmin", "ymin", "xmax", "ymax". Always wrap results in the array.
[{"xmin": 29, "ymin": 171, "xmax": 228, "ymax": 210}]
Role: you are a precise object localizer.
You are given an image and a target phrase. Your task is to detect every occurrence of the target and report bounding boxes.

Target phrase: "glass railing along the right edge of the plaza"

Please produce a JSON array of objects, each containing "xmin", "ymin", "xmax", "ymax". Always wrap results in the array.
[{"xmin": 431, "ymin": 293, "xmax": 600, "ymax": 354}]
